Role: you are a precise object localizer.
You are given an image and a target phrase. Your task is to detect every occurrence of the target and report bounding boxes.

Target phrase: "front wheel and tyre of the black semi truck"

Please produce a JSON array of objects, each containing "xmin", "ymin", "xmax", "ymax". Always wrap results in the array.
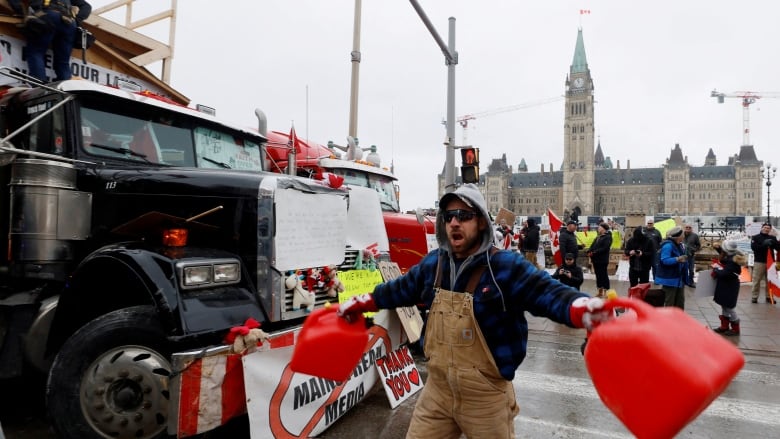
[{"xmin": 46, "ymin": 306, "xmax": 173, "ymax": 439}]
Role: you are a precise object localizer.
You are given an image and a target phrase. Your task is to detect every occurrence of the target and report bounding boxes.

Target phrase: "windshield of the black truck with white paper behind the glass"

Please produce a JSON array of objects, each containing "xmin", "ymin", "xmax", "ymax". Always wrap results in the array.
[{"xmin": 81, "ymin": 102, "xmax": 262, "ymax": 171}]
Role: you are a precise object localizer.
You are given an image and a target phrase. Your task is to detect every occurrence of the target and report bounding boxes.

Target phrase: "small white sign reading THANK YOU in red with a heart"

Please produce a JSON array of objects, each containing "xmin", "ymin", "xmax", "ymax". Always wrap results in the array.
[{"xmin": 376, "ymin": 346, "xmax": 423, "ymax": 408}]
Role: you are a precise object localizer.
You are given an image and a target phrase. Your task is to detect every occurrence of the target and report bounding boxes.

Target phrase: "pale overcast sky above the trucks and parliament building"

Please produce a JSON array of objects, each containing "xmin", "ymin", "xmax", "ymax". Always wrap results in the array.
[{"xmin": 92, "ymin": 0, "xmax": 780, "ymax": 213}]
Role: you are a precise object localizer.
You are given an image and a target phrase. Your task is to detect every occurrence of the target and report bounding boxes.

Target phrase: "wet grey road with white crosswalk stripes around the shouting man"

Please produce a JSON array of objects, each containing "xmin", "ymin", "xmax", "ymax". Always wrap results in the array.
[{"xmin": 321, "ymin": 332, "xmax": 780, "ymax": 439}]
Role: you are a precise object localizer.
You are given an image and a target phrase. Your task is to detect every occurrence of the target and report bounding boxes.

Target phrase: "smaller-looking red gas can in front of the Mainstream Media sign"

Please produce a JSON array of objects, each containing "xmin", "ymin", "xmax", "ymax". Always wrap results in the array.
[{"xmin": 290, "ymin": 306, "xmax": 368, "ymax": 381}]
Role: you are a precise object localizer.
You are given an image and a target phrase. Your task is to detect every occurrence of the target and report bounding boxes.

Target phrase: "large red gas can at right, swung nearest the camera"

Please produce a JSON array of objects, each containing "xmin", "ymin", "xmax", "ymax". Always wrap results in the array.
[{"xmin": 585, "ymin": 298, "xmax": 745, "ymax": 438}]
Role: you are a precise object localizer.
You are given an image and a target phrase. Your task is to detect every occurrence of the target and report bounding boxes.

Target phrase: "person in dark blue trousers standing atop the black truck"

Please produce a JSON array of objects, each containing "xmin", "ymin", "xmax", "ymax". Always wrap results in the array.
[{"xmin": 25, "ymin": 0, "xmax": 92, "ymax": 82}]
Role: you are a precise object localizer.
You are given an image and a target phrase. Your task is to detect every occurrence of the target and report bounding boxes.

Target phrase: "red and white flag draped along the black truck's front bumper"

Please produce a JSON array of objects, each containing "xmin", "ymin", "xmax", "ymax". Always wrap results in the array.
[{"xmin": 176, "ymin": 331, "xmax": 298, "ymax": 438}]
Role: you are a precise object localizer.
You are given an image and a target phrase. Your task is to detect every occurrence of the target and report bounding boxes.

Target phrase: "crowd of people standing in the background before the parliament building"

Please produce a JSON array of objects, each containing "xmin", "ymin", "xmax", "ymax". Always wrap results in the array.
[{"xmin": 484, "ymin": 213, "xmax": 780, "ymax": 312}]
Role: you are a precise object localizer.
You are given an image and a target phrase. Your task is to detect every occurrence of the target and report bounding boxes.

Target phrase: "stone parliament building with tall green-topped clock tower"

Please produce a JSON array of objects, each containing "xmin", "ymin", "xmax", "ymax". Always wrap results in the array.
[{"xmin": 438, "ymin": 29, "xmax": 763, "ymax": 218}]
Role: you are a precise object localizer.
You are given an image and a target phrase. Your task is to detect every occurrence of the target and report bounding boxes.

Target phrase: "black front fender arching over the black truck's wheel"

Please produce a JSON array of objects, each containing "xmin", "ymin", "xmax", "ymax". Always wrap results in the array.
[{"xmin": 47, "ymin": 244, "xmax": 265, "ymax": 360}]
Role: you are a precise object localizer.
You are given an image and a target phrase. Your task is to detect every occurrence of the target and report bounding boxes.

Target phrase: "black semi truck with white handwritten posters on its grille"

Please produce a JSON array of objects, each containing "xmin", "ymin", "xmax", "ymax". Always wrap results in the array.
[{"xmin": 0, "ymin": 67, "xmax": 387, "ymax": 439}]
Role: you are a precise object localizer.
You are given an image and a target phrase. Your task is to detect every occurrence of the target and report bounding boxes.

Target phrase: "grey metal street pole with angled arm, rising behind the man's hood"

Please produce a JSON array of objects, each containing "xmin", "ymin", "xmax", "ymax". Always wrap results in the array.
[{"xmin": 409, "ymin": 0, "xmax": 458, "ymax": 192}]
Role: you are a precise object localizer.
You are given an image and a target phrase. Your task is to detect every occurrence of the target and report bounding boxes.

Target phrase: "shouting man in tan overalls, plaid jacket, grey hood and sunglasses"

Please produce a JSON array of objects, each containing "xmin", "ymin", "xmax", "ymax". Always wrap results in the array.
[{"xmin": 338, "ymin": 184, "xmax": 608, "ymax": 438}]
